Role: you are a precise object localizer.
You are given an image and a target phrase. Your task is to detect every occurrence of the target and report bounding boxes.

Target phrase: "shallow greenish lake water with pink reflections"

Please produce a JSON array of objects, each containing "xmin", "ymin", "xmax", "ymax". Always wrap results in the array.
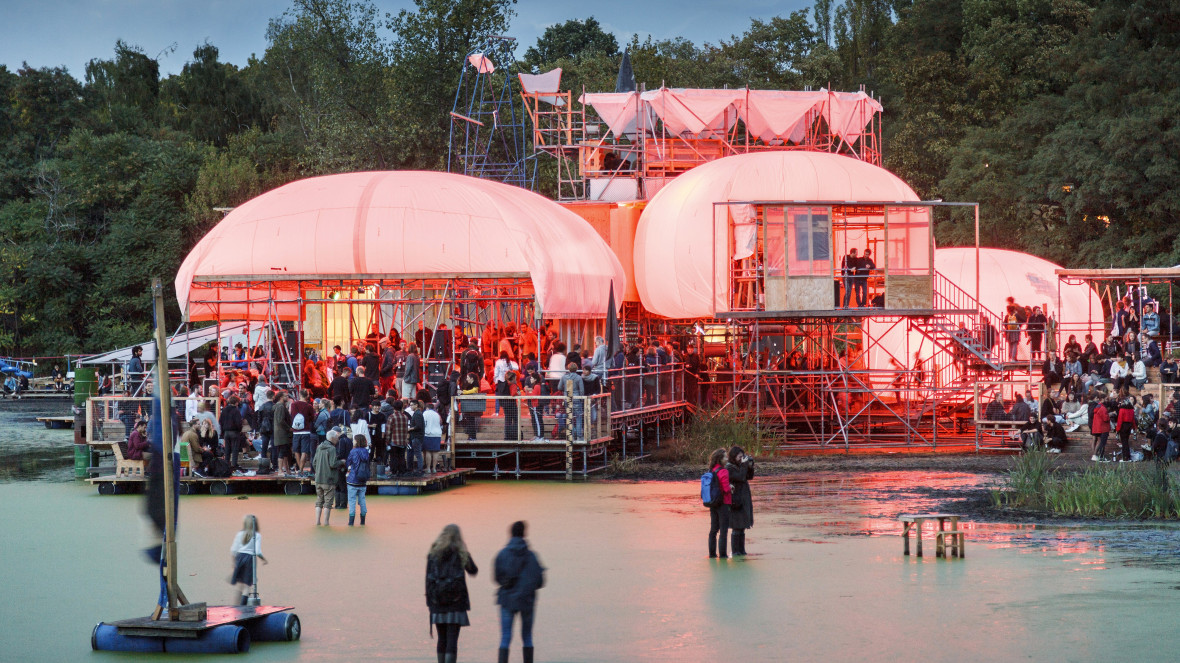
[{"xmin": 0, "ymin": 396, "xmax": 1180, "ymax": 663}]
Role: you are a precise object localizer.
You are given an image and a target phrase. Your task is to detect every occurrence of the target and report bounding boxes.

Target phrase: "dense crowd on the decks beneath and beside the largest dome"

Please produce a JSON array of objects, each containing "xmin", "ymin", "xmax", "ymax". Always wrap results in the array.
[{"xmin": 112, "ymin": 323, "xmax": 695, "ymax": 493}]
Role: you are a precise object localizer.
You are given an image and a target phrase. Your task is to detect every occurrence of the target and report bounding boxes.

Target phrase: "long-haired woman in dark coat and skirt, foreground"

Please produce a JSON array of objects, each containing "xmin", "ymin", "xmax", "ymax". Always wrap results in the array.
[{"xmin": 426, "ymin": 525, "xmax": 479, "ymax": 663}]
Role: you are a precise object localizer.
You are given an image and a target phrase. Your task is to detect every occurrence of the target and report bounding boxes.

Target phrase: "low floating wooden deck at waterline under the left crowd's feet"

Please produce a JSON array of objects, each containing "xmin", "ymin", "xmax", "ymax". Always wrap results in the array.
[{"xmin": 86, "ymin": 467, "xmax": 474, "ymax": 495}]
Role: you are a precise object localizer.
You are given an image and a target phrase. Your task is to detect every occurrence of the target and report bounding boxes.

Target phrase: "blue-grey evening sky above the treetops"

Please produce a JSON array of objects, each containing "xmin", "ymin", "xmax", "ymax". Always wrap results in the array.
[{"xmin": 0, "ymin": 0, "xmax": 811, "ymax": 79}]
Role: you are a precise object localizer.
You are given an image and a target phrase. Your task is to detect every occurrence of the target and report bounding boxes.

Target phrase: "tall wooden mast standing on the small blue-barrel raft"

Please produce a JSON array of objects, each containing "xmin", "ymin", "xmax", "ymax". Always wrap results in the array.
[{"xmin": 151, "ymin": 278, "xmax": 188, "ymax": 621}]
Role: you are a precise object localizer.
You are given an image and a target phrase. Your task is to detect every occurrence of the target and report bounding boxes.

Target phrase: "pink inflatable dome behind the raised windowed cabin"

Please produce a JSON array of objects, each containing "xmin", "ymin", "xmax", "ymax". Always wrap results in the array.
[{"xmin": 635, "ymin": 151, "xmax": 918, "ymax": 319}]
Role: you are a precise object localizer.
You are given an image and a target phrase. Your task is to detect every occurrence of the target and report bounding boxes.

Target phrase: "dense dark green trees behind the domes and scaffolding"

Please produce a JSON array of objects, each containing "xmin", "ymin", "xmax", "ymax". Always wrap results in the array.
[{"xmin": 0, "ymin": 0, "xmax": 1180, "ymax": 355}]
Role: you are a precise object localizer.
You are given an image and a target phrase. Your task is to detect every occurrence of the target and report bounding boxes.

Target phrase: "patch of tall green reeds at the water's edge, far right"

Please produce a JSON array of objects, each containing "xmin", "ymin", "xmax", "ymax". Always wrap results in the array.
[{"xmin": 991, "ymin": 451, "xmax": 1180, "ymax": 519}]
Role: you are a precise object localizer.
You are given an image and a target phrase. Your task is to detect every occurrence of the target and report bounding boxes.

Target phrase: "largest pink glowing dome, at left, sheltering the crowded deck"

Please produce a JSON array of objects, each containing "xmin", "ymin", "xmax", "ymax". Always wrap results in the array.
[{"xmin": 176, "ymin": 171, "xmax": 627, "ymax": 320}]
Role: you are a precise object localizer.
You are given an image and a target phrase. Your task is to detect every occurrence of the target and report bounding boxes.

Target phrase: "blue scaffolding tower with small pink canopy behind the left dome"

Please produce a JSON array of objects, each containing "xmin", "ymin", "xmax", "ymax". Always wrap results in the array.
[{"xmin": 447, "ymin": 37, "xmax": 537, "ymax": 190}]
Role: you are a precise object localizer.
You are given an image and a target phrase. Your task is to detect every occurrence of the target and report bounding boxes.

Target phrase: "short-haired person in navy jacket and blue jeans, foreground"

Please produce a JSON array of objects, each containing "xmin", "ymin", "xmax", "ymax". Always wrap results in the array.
[{"xmin": 496, "ymin": 520, "xmax": 545, "ymax": 663}]
